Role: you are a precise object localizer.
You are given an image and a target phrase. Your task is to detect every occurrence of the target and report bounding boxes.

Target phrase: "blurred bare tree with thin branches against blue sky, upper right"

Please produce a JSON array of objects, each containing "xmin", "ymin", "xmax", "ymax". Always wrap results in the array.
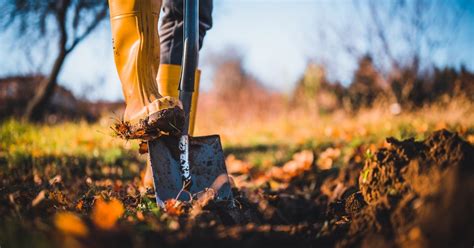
[{"xmin": 359, "ymin": 0, "xmax": 463, "ymax": 106}]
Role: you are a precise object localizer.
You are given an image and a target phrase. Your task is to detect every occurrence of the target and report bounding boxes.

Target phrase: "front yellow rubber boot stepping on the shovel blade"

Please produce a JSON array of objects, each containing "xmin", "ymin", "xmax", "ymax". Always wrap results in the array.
[{"xmin": 109, "ymin": 0, "xmax": 181, "ymax": 128}]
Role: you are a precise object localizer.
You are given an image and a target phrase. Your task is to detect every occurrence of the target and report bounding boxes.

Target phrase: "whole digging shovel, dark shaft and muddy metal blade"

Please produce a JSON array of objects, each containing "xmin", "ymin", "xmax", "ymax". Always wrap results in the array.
[{"xmin": 148, "ymin": 0, "xmax": 232, "ymax": 207}]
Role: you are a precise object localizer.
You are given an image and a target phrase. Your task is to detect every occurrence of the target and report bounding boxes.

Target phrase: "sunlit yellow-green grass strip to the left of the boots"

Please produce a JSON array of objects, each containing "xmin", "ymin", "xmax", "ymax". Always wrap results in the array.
[{"xmin": 0, "ymin": 120, "xmax": 133, "ymax": 163}]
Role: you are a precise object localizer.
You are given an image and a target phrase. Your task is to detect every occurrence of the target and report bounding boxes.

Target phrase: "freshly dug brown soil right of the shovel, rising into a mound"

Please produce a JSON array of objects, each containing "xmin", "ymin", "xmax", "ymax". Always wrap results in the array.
[{"xmin": 161, "ymin": 130, "xmax": 474, "ymax": 247}]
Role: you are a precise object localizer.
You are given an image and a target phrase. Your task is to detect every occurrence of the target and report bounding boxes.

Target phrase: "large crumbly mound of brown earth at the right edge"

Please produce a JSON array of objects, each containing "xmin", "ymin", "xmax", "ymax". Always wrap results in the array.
[{"xmin": 341, "ymin": 130, "xmax": 474, "ymax": 247}]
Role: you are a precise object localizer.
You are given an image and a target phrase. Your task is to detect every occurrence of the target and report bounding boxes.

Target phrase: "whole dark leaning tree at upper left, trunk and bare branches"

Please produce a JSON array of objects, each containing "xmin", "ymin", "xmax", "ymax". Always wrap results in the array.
[{"xmin": 0, "ymin": 0, "xmax": 108, "ymax": 121}]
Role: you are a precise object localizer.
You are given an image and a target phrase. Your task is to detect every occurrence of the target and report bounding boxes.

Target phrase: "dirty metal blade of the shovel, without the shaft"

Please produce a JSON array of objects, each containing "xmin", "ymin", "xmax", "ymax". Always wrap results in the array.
[{"xmin": 148, "ymin": 135, "xmax": 232, "ymax": 205}]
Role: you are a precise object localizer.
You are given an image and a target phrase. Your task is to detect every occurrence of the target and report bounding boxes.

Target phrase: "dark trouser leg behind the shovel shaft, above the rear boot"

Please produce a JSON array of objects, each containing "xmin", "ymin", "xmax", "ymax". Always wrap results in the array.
[{"xmin": 159, "ymin": 0, "xmax": 212, "ymax": 65}]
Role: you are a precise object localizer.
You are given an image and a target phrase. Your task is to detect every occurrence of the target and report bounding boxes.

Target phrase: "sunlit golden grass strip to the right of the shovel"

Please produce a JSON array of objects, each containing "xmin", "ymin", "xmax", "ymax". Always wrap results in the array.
[{"xmin": 196, "ymin": 100, "xmax": 474, "ymax": 166}]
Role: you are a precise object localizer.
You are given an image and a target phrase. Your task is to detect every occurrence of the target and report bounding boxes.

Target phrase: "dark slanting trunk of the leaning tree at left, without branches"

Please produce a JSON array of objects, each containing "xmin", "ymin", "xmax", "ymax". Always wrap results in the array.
[{"xmin": 23, "ymin": 48, "xmax": 68, "ymax": 121}]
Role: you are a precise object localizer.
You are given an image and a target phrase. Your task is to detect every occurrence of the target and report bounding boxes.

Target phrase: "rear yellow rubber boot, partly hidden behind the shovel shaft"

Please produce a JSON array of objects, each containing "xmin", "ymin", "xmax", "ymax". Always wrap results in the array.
[{"xmin": 156, "ymin": 64, "xmax": 201, "ymax": 136}]
